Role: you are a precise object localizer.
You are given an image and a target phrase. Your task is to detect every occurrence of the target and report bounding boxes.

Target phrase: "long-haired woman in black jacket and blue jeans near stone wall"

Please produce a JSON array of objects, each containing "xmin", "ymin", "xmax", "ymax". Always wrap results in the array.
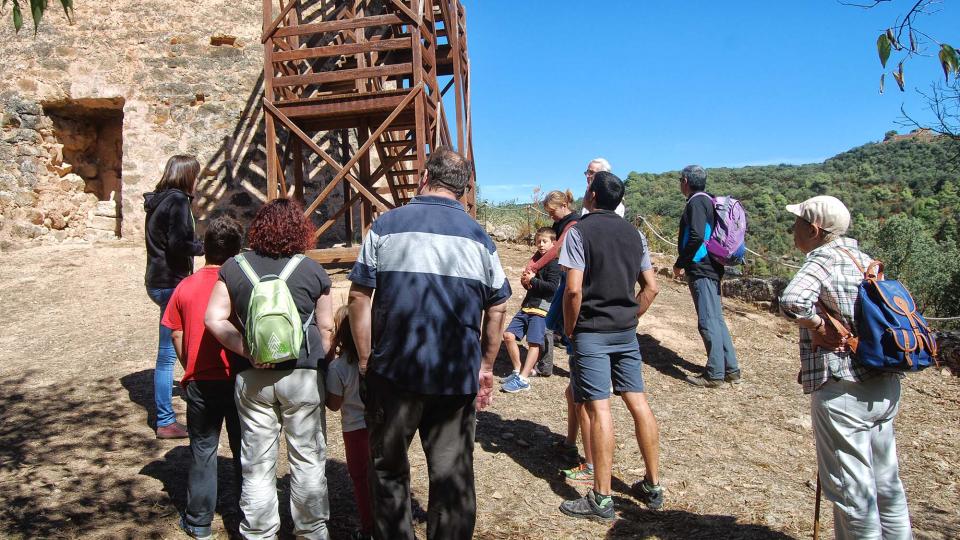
[{"xmin": 143, "ymin": 155, "xmax": 203, "ymax": 439}]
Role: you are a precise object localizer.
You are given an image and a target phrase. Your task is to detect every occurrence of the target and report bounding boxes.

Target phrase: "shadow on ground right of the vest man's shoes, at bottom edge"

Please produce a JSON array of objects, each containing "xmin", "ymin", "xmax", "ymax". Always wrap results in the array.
[{"xmin": 606, "ymin": 496, "xmax": 793, "ymax": 540}]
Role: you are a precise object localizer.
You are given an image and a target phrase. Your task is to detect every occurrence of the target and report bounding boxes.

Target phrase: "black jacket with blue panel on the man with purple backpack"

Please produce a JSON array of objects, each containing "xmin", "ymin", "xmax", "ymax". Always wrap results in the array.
[{"xmin": 674, "ymin": 193, "xmax": 723, "ymax": 280}]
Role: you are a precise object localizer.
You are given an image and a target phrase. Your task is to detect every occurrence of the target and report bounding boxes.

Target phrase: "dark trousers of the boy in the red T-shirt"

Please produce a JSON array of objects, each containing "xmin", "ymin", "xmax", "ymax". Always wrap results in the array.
[{"xmin": 185, "ymin": 380, "xmax": 241, "ymax": 527}]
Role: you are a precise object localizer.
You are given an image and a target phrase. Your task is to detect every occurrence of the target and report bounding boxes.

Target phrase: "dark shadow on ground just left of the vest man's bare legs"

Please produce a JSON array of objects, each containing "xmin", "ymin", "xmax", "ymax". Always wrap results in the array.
[{"xmin": 476, "ymin": 411, "xmax": 629, "ymax": 499}]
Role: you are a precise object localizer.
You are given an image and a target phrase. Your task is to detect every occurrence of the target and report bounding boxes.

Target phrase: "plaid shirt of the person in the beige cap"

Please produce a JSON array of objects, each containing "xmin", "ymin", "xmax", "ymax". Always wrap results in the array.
[{"xmin": 780, "ymin": 237, "xmax": 873, "ymax": 394}]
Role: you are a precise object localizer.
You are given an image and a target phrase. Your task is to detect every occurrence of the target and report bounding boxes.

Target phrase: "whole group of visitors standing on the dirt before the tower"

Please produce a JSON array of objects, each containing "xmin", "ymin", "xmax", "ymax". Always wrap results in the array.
[{"xmin": 146, "ymin": 147, "xmax": 910, "ymax": 539}]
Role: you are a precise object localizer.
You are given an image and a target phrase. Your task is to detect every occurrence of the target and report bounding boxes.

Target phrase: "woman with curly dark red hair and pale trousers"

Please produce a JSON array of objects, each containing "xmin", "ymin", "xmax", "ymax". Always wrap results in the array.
[{"xmin": 205, "ymin": 199, "xmax": 333, "ymax": 539}]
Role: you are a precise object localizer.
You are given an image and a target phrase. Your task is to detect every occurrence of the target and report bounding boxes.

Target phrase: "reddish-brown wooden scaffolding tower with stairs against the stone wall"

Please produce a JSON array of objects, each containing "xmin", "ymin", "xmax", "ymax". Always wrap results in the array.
[{"xmin": 262, "ymin": 0, "xmax": 476, "ymax": 262}]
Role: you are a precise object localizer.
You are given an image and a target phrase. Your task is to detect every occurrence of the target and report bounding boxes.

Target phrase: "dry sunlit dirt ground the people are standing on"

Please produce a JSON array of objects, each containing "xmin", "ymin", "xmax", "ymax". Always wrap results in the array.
[{"xmin": 0, "ymin": 244, "xmax": 960, "ymax": 539}]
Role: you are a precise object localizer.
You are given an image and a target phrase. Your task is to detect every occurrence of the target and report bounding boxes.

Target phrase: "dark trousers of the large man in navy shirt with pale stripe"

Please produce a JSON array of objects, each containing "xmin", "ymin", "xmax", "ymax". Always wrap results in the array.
[{"xmin": 365, "ymin": 373, "xmax": 477, "ymax": 540}]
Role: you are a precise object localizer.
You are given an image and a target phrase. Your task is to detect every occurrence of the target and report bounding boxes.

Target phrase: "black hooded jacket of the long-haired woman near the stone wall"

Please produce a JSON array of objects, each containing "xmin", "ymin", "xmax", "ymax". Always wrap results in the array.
[{"xmin": 143, "ymin": 189, "xmax": 203, "ymax": 289}]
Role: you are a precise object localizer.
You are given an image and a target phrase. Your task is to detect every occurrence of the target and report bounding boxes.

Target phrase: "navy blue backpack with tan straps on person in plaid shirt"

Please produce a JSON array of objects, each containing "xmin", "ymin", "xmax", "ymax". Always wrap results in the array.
[{"xmin": 827, "ymin": 248, "xmax": 937, "ymax": 373}]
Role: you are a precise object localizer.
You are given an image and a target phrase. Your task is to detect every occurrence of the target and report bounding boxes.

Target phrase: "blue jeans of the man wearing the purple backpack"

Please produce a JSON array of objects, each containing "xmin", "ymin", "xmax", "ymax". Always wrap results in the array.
[{"xmin": 687, "ymin": 278, "xmax": 740, "ymax": 380}]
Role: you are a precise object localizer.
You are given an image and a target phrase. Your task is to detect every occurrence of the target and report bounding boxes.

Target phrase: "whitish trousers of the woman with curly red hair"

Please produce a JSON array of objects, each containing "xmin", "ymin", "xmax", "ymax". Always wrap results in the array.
[{"xmin": 235, "ymin": 368, "xmax": 330, "ymax": 540}]
